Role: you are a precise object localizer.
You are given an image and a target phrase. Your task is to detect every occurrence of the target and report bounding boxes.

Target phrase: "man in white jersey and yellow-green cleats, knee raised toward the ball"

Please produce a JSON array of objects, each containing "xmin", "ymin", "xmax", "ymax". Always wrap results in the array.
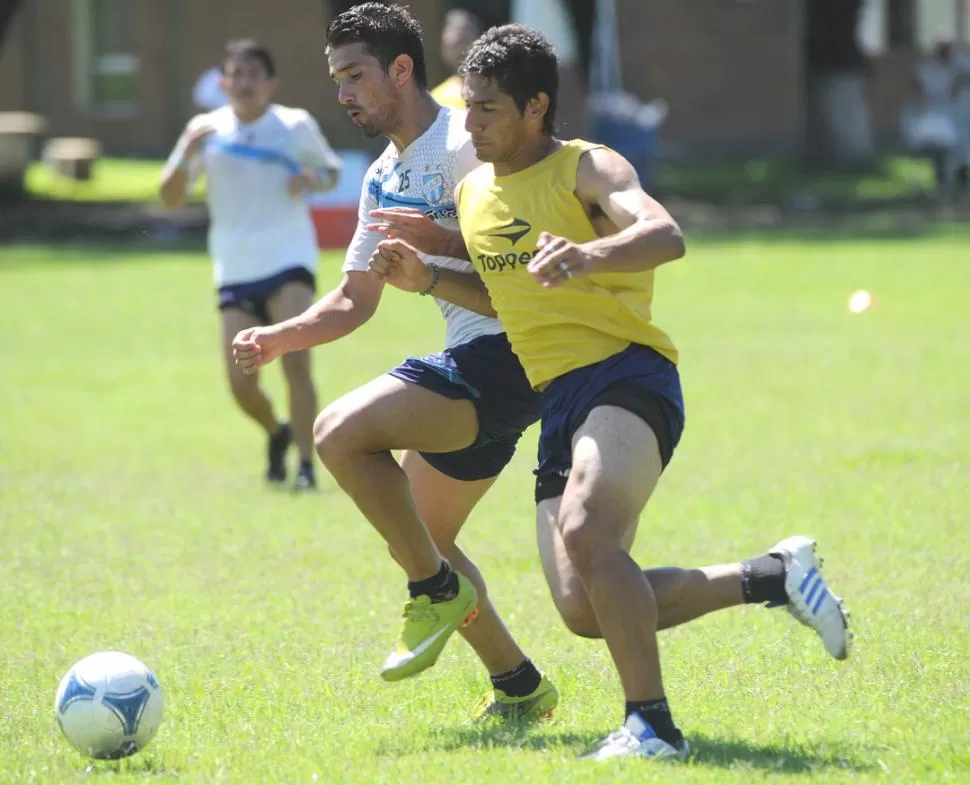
[{"xmin": 234, "ymin": 3, "xmax": 559, "ymax": 719}]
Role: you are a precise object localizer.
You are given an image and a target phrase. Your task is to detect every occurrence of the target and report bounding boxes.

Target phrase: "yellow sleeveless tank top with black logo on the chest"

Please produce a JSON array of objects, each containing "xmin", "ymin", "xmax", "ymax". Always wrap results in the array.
[{"xmin": 458, "ymin": 139, "xmax": 677, "ymax": 388}]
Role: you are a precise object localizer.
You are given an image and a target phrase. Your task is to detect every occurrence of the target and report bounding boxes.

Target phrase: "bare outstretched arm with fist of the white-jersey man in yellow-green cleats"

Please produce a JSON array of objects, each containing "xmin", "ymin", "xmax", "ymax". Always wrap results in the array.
[{"xmin": 232, "ymin": 270, "xmax": 384, "ymax": 374}]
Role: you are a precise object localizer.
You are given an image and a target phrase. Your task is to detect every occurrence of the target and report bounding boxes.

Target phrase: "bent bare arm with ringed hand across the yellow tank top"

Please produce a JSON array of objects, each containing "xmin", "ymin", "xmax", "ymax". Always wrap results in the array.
[{"xmin": 528, "ymin": 148, "xmax": 685, "ymax": 286}]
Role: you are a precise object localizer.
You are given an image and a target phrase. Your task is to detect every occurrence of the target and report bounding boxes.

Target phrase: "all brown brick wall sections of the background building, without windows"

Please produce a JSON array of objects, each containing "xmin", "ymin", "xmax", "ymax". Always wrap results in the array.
[{"xmin": 0, "ymin": 0, "xmax": 913, "ymax": 156}]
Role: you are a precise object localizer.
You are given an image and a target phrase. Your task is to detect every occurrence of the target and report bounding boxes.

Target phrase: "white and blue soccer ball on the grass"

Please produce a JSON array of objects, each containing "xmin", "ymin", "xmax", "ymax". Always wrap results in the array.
[{"xmin": 54, "ymin": 651, "xmax": 165, "ymax": 760}]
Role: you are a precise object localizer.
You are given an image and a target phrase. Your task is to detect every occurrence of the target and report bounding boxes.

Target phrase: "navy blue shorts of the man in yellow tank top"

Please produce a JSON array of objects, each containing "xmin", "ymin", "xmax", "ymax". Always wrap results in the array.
[{"xmin": 535, "ymin": 344, "xmax": 684, "ymax": 504}]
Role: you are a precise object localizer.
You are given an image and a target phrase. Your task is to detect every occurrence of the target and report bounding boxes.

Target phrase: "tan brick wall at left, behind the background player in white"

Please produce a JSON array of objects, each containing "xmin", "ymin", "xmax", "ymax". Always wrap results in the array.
[{"xmin": 0, "ymin": 0, "xmax": 441, "ymax": 156}]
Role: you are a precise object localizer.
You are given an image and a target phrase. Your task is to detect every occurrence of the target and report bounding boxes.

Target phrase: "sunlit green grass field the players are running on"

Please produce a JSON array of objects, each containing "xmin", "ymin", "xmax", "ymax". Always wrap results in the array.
[{"xmin": 0, "ymin": 230, "xmax": 970, "ymax": 785}]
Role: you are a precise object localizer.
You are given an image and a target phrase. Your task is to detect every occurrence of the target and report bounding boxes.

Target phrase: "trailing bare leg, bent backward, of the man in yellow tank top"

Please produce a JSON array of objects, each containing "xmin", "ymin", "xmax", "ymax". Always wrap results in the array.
[{"xmin": 536, "ymin": 508, "xmax": 743, "ymax": 638}]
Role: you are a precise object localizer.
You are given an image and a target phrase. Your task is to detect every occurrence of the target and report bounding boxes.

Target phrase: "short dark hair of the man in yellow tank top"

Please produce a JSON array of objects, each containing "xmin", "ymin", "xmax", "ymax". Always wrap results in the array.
[{"xmin": 458, "ymin": 24, "xmax": 559, "ymax": 136}]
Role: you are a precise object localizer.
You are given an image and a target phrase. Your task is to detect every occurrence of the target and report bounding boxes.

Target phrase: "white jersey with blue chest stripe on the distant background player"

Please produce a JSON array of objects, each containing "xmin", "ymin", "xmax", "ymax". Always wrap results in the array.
[{"xmin": 168, "ymin": 104, "xmax": 340, "ymax": 286}]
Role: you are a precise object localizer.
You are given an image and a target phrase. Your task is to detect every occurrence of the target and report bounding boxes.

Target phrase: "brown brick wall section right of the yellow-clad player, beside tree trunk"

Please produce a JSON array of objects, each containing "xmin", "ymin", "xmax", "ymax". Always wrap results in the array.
[{"xmin": 618, "ymin": 0, "xmax": 802, "ymax": 157}]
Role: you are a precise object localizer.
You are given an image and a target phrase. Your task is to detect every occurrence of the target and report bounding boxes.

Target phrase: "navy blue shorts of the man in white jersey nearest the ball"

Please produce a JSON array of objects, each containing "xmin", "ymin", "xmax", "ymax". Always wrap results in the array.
[{"xmin": 389, "ymin": 334, "xmax": 540, "ymax": 480}]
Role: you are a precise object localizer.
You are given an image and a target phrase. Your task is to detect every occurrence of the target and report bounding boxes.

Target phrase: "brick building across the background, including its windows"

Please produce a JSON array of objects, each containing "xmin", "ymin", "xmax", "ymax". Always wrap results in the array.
[{"xmin": 0, "ymin": 0, "xmax": 970, "ymax": 157}]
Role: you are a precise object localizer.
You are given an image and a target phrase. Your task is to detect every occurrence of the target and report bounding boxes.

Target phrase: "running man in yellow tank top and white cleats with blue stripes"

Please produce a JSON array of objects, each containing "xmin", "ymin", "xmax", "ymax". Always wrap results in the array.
[{"xmin": 371, "ymin": 25, "xmax": 849, "ymax": 760}]
